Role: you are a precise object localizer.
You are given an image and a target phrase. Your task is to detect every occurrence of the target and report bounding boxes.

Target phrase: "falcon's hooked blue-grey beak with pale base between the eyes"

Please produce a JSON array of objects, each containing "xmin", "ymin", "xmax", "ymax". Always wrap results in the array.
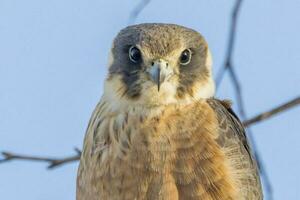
[{"xmin": 147, "ymin": 59, "xmax": 171, "ymax": 91}]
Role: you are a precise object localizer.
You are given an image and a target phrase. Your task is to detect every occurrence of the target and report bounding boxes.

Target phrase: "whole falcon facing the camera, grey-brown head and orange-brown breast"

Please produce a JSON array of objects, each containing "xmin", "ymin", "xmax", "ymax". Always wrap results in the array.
[{"xmin": 76, "ymin": 23, "xmax": 263, "ymax": 200}]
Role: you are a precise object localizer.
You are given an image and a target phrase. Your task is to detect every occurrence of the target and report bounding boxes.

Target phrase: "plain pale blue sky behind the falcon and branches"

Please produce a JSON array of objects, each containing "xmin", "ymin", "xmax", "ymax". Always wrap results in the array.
[{"xmin": 0, "ymin": 0, "xmax": 300, "ymax": 200}]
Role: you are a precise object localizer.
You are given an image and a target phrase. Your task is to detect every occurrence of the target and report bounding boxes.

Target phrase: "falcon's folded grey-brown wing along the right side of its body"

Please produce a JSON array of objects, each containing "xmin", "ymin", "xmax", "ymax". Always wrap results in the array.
[{"xmin": 208, "ymin": 99, "xmax": 263, "ymax": 199}]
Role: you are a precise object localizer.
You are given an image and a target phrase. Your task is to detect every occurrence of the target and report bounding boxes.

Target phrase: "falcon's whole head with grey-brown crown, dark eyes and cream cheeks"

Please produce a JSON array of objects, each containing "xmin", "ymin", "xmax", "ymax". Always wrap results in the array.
[{"xmin": 104, "ymin": 24, "xmax": 215, "ymax": 110}]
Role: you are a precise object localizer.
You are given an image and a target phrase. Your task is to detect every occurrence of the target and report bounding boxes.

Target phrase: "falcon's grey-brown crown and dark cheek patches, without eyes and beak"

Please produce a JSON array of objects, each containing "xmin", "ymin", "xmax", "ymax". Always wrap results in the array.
[{"xmin": 109, "ymin": 24, "xmax": 209, "ymax": 99}]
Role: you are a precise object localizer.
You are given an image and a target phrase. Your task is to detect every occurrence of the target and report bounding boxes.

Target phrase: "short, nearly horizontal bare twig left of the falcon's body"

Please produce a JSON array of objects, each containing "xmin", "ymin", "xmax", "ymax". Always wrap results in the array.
[{"xmin": 0, "ymin": 148, "xmax": 81, "ymax": 169}]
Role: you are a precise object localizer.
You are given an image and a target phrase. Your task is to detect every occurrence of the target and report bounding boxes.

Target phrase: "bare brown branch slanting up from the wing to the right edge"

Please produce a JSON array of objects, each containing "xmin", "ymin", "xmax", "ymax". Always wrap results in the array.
[{"xmin": 243, "ymin": 96, "xmax": 300, "ymax": 126}]
